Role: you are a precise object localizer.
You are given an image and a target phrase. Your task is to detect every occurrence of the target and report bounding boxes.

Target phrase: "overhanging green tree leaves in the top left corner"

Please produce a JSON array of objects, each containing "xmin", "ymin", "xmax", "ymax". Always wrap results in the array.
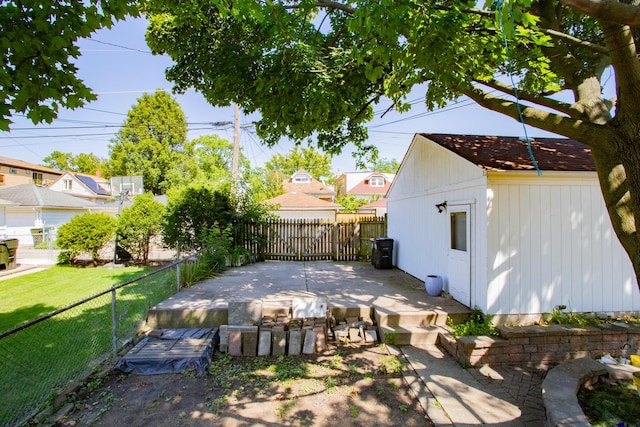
[{"xmin": 0, "ymin": 0, "xmax": 138, "ymax": 131}]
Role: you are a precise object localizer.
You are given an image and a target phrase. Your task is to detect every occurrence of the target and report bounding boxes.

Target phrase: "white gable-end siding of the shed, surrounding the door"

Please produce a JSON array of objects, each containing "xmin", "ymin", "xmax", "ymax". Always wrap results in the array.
[{"xmin": 387, "ymin": 135, "xmax": 486, "ymax": 307}]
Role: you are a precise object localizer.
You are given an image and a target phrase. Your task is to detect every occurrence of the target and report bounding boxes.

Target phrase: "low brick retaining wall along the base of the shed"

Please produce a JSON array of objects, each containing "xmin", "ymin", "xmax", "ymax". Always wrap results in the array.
[{"xmin": 440, "ymin": 324, "xmax": 640, "ymax": 369}]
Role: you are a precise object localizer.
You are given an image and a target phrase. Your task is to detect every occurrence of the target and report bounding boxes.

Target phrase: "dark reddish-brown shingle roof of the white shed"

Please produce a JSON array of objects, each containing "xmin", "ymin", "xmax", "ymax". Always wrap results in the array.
[{"xmin": 420, "ymin": 133, "xmax": 596, "ymax": 171}]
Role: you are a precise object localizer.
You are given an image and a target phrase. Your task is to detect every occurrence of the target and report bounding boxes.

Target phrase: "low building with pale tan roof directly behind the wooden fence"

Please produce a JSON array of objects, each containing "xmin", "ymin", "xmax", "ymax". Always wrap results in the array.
[{"xmin": 263, "ymin": 192, "xmax": 342, "ymax": 221}]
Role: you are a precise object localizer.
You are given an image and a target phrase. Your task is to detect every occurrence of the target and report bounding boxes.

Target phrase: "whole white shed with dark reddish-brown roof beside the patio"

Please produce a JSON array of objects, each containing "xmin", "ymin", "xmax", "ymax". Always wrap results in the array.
[{"xmin": 387, "ymin": 134, "xmax": 640, "ymax": 322}]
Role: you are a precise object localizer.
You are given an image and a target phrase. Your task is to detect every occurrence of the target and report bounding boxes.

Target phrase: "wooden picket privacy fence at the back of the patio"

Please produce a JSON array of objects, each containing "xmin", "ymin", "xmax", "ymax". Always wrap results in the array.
[{"xmin": 235, "ymin": 217, "xmax": 387, "ymax": 261}]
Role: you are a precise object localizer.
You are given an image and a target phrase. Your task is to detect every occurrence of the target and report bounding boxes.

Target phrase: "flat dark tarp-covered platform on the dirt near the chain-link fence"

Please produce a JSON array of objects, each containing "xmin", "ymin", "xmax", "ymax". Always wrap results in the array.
[{"xmin": 115, "ymin": 328, "xmax": 219, "ymax": 377}]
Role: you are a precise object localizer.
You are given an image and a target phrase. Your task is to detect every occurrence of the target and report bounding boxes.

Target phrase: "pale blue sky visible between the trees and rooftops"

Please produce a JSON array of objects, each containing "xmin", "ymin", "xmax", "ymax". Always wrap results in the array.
[{"xmin": 0, "ymin": 15, "xmax": 584, "ymax": 173}]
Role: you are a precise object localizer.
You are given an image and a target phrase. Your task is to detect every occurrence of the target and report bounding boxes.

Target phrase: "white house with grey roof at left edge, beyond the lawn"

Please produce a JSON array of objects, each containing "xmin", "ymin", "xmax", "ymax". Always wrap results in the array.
[{"xmin": 0, "ymin": 184, "xmax": 99, "ymax": 245}]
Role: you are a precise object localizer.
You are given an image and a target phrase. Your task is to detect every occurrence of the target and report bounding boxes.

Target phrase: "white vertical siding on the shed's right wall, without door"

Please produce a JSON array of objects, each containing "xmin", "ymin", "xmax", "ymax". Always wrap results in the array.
[{"xmin": 487, "ymin": 173, "xmax": 640, "ymax": 314}]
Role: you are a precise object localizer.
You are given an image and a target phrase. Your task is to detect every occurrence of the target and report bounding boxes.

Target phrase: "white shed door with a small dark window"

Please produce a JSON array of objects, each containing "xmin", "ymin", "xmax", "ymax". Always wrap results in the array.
[{"xmin": 447, "ymin": 205, "xmax": 471, "ymax": 307}]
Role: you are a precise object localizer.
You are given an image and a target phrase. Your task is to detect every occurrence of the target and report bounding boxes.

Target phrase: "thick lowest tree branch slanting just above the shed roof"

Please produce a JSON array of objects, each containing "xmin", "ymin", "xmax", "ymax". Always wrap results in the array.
[{"xmin": 458, "ymin": 86, "xmax": 610, "ymax": 150}]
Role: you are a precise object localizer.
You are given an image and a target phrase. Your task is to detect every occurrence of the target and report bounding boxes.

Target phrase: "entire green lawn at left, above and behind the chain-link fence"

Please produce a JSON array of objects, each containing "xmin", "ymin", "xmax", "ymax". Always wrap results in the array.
[{"xmin": 0, "ymin": 266, "xmax": 176, "ymax": 425}]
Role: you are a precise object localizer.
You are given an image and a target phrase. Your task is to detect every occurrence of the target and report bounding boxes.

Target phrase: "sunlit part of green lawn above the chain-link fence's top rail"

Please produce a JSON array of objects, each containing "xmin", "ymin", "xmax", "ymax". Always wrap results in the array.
[{"xmin": 0, "ymin": 266, "xmax": 151, "ymax": 332}]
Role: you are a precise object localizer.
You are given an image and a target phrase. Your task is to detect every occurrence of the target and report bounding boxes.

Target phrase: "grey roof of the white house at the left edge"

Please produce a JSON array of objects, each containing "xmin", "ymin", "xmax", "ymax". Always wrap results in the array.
[{"xmin": 0, "ymin": 184, "xmax": 98, "ymax": 208}]
